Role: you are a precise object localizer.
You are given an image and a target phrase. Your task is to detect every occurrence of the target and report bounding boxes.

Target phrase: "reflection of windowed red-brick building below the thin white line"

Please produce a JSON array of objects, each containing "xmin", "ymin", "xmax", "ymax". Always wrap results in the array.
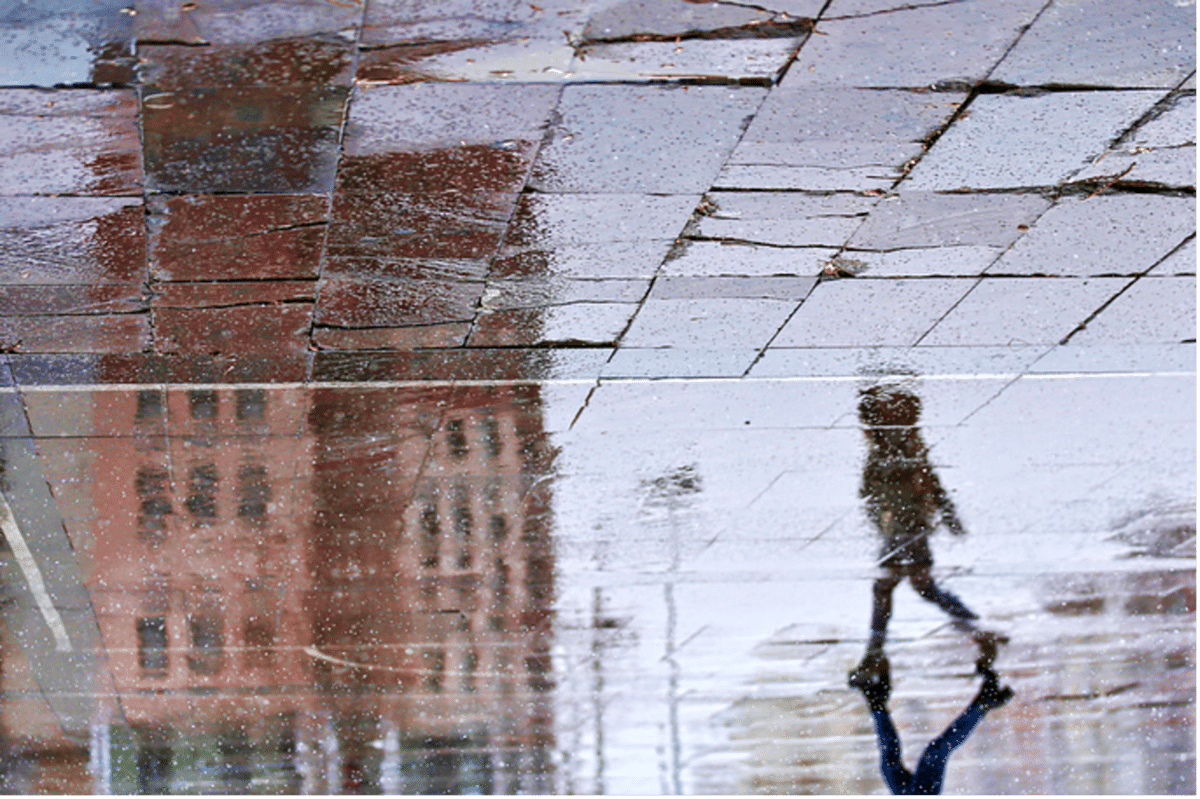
[{"xmin": 73, "ymin": 386, "xmax": 553, "ymax": 793}]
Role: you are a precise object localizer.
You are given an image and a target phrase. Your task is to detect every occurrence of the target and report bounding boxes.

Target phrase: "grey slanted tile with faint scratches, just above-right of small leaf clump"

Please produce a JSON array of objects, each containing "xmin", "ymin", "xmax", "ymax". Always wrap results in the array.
[{"xmin": 850, "ymin": 191, "xmax": 1050, "ymax": 251}]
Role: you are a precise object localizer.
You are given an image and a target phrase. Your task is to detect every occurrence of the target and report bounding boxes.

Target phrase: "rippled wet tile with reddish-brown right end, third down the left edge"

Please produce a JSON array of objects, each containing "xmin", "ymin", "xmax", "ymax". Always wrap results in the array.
[{"xmin": 0, "ymin": 197, "xmax": 145, "ymax": 284}]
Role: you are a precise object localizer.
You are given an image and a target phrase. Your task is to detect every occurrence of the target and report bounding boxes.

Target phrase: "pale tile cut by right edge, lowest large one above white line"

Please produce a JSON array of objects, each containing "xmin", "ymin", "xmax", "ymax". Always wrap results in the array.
[{"xmin": 1069, "ymin": 276, "xmax": 1196, "ymax": 347}]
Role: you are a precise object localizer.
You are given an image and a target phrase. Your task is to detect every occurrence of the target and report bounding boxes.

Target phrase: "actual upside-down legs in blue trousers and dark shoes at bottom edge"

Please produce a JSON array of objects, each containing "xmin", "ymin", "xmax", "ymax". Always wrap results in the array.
[{"xmin": 851, "ymin": 657, "xmax": 1013, "ymax": 795}]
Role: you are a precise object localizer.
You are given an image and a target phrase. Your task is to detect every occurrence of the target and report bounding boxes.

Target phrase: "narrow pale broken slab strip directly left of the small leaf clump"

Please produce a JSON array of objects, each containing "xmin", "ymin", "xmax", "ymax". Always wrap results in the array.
[{"xmin": 662, "ymin": 240, "xmax": 838, "ymax": 277}]
